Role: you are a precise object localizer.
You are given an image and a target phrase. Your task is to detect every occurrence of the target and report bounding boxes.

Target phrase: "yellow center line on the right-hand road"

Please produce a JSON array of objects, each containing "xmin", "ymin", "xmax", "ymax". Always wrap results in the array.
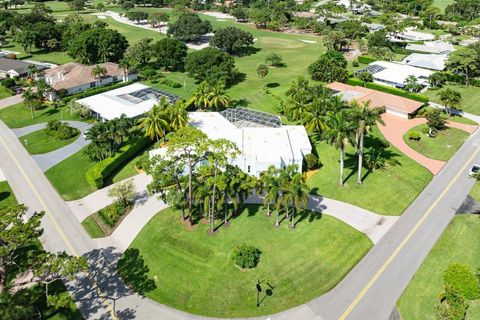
[{"xmin": 338, "ymin": 148, "xmax": 480, "ymax": 320}]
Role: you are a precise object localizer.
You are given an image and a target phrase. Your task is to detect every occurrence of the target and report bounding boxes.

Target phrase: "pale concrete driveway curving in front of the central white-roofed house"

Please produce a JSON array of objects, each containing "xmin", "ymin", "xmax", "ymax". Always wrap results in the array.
[{"xmin": 67, "ymin": 173, "xmax": 398, "ymax": 251}]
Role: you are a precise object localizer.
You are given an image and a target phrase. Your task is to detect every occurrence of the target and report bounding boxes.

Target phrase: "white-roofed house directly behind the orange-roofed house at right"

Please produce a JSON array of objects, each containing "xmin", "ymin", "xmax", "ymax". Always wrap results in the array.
[{"xmin": 354, "ymin": 61, "xmax": 433, "ymax": 88}]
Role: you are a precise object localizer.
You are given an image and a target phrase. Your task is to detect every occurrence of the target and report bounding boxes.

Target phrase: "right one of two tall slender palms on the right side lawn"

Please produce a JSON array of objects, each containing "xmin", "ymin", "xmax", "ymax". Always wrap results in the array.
[{"xmin": 350, "ymin": 100, "xmax": 385, "ymax": 184}]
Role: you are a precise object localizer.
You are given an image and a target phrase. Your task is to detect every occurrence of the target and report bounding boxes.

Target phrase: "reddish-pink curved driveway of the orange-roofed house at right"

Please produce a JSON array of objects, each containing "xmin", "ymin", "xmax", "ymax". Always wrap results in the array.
[{"xmin": 378, "ymin": 113, "xmax": 478, "ymax": 175}]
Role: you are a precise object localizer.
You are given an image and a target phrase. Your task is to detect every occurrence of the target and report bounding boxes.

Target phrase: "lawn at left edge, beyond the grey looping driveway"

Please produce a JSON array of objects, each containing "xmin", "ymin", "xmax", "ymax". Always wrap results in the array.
[{"xmin": 0, "ymin": 102, "xmax": 79, "ymax": 128}]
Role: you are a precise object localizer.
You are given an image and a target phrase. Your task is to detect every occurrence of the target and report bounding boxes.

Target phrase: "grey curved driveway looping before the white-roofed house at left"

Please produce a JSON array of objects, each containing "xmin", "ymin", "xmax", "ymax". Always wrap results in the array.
[{"xmin": 12, "ymin": 121, "xmax": 92, "ymax": 172}]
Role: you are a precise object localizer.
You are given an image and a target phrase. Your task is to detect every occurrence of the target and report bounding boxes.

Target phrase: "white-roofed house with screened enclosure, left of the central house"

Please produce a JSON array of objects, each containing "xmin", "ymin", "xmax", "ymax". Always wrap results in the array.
[{"xmin": 77, "ymin": 83, "xmax": 180, "ymax": 121}]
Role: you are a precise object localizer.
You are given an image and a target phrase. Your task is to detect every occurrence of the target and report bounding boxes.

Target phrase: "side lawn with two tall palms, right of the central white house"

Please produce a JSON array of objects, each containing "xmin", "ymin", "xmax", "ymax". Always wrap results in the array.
[{"xmin": 307, "ymin": 128, "xmax": 432, "ymax": 215}]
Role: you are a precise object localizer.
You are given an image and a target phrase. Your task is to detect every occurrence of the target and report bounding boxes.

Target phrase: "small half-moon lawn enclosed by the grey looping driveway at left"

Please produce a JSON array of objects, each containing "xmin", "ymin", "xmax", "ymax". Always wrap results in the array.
[{"xmin": 18, "ymin": 129, "xmax": 80, "ymax": 154}]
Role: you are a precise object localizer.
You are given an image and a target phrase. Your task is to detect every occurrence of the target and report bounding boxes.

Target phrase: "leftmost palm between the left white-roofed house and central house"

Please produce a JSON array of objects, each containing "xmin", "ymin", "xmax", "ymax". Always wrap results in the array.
[{"xmin": 138, "ymin": 97, "xmax": 170, "ymax": 145}]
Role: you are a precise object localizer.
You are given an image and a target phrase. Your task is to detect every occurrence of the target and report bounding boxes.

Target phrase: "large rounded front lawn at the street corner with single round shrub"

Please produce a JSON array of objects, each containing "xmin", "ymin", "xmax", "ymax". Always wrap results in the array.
[{"xmin": 131, "ymin": 206, "xmax": 372, "ymax": 317}]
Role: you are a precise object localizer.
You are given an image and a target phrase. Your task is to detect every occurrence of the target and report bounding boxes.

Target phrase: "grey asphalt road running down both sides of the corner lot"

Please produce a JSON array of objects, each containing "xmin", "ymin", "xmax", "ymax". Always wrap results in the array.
[{"xmin": 0, "ymin": 113, "xmax": 480, "ymax": 320}]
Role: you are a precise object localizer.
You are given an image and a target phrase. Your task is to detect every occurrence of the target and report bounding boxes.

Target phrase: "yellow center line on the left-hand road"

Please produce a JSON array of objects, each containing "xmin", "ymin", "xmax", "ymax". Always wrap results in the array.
[{"xmin": 0, "ymin": 136, "xmax": 118, "ymax": 319}]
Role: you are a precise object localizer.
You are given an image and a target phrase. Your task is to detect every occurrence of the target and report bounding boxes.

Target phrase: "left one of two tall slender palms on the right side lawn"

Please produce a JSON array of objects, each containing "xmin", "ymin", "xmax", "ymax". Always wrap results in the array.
[{"xmin": 324, "ymin": 110, "xmax": 353, "ymax": 187}]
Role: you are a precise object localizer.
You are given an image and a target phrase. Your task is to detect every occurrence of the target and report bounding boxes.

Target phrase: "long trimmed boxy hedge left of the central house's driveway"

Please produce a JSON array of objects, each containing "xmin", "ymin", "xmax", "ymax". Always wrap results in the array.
[{"xmin": 85, "ymin": 137, "xmax": 151, "ymax": 189}]
